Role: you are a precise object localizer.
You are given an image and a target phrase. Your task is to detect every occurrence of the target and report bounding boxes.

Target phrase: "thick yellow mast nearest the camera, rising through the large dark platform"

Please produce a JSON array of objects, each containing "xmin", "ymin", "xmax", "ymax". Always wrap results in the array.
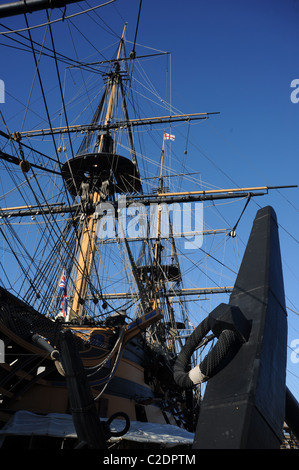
[{"xmin": 72, "ymin": 25, "xmax": 126, "ymax": 315}]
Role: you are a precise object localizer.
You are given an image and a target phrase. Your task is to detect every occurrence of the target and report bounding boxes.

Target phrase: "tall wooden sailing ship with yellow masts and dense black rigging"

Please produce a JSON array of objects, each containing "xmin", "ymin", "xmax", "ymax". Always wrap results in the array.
[{"xmin": 0, "ymin": 0, "xmax": 298, "ymax": 448}]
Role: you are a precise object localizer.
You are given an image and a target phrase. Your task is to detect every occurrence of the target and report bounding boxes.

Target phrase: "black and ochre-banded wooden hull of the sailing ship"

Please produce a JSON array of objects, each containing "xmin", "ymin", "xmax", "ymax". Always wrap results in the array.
[{"xmin": 0, "ymin": 291, "xmax": 182, "ymax": 425}]
